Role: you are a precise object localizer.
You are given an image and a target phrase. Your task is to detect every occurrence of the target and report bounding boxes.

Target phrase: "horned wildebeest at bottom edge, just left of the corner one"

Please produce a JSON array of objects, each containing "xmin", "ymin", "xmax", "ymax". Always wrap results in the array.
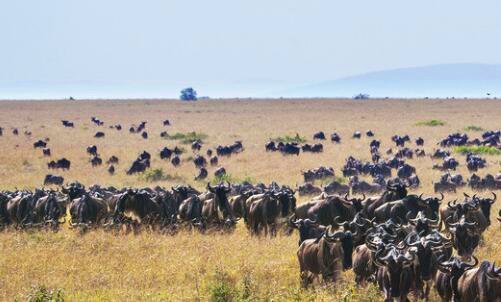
[{"xmin": 435, "ymin": 256, "xmax": 478, "ymax": 302}]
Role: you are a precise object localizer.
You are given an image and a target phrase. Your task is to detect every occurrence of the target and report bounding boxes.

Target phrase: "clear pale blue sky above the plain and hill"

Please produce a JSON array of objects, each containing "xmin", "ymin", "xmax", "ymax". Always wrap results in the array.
[{"xmin": 0, "ymin": 0, "xmax": 501, "ymax": 98}]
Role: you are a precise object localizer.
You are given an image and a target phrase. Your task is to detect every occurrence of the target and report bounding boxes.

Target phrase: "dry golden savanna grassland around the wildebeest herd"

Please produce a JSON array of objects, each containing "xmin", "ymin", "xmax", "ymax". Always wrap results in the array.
[{"xmin": 0, "ymin": 100, "xmax": 501, "ymax": 301}]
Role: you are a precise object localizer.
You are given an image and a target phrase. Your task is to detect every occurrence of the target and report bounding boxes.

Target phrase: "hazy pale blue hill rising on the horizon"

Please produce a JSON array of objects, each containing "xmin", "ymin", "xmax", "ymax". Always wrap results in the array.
[{"xmin": 278, "ymin": 64, "xmax": 501, "ymax": 98}]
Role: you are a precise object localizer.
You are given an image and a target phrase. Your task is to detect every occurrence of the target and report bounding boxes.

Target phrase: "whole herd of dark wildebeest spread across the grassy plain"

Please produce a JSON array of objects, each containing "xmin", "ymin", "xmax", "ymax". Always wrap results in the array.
[{"xmin": 0, "ymin": 118, "xmax": 501, "ymax": 302}]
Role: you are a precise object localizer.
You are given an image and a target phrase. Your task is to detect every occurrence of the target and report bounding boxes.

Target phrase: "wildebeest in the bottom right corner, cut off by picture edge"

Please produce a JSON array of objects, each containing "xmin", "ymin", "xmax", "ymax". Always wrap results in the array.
[{"xmin": 457, "ymin": 261, "xmax": 501, "ymax": 302}]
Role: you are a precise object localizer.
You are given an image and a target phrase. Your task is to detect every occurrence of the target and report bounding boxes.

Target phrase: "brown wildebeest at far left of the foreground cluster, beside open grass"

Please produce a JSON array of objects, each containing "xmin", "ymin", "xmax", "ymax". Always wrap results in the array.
[{"xmin": 297, "ymin": 228, "xmax": 353, "ymax": 287}]
